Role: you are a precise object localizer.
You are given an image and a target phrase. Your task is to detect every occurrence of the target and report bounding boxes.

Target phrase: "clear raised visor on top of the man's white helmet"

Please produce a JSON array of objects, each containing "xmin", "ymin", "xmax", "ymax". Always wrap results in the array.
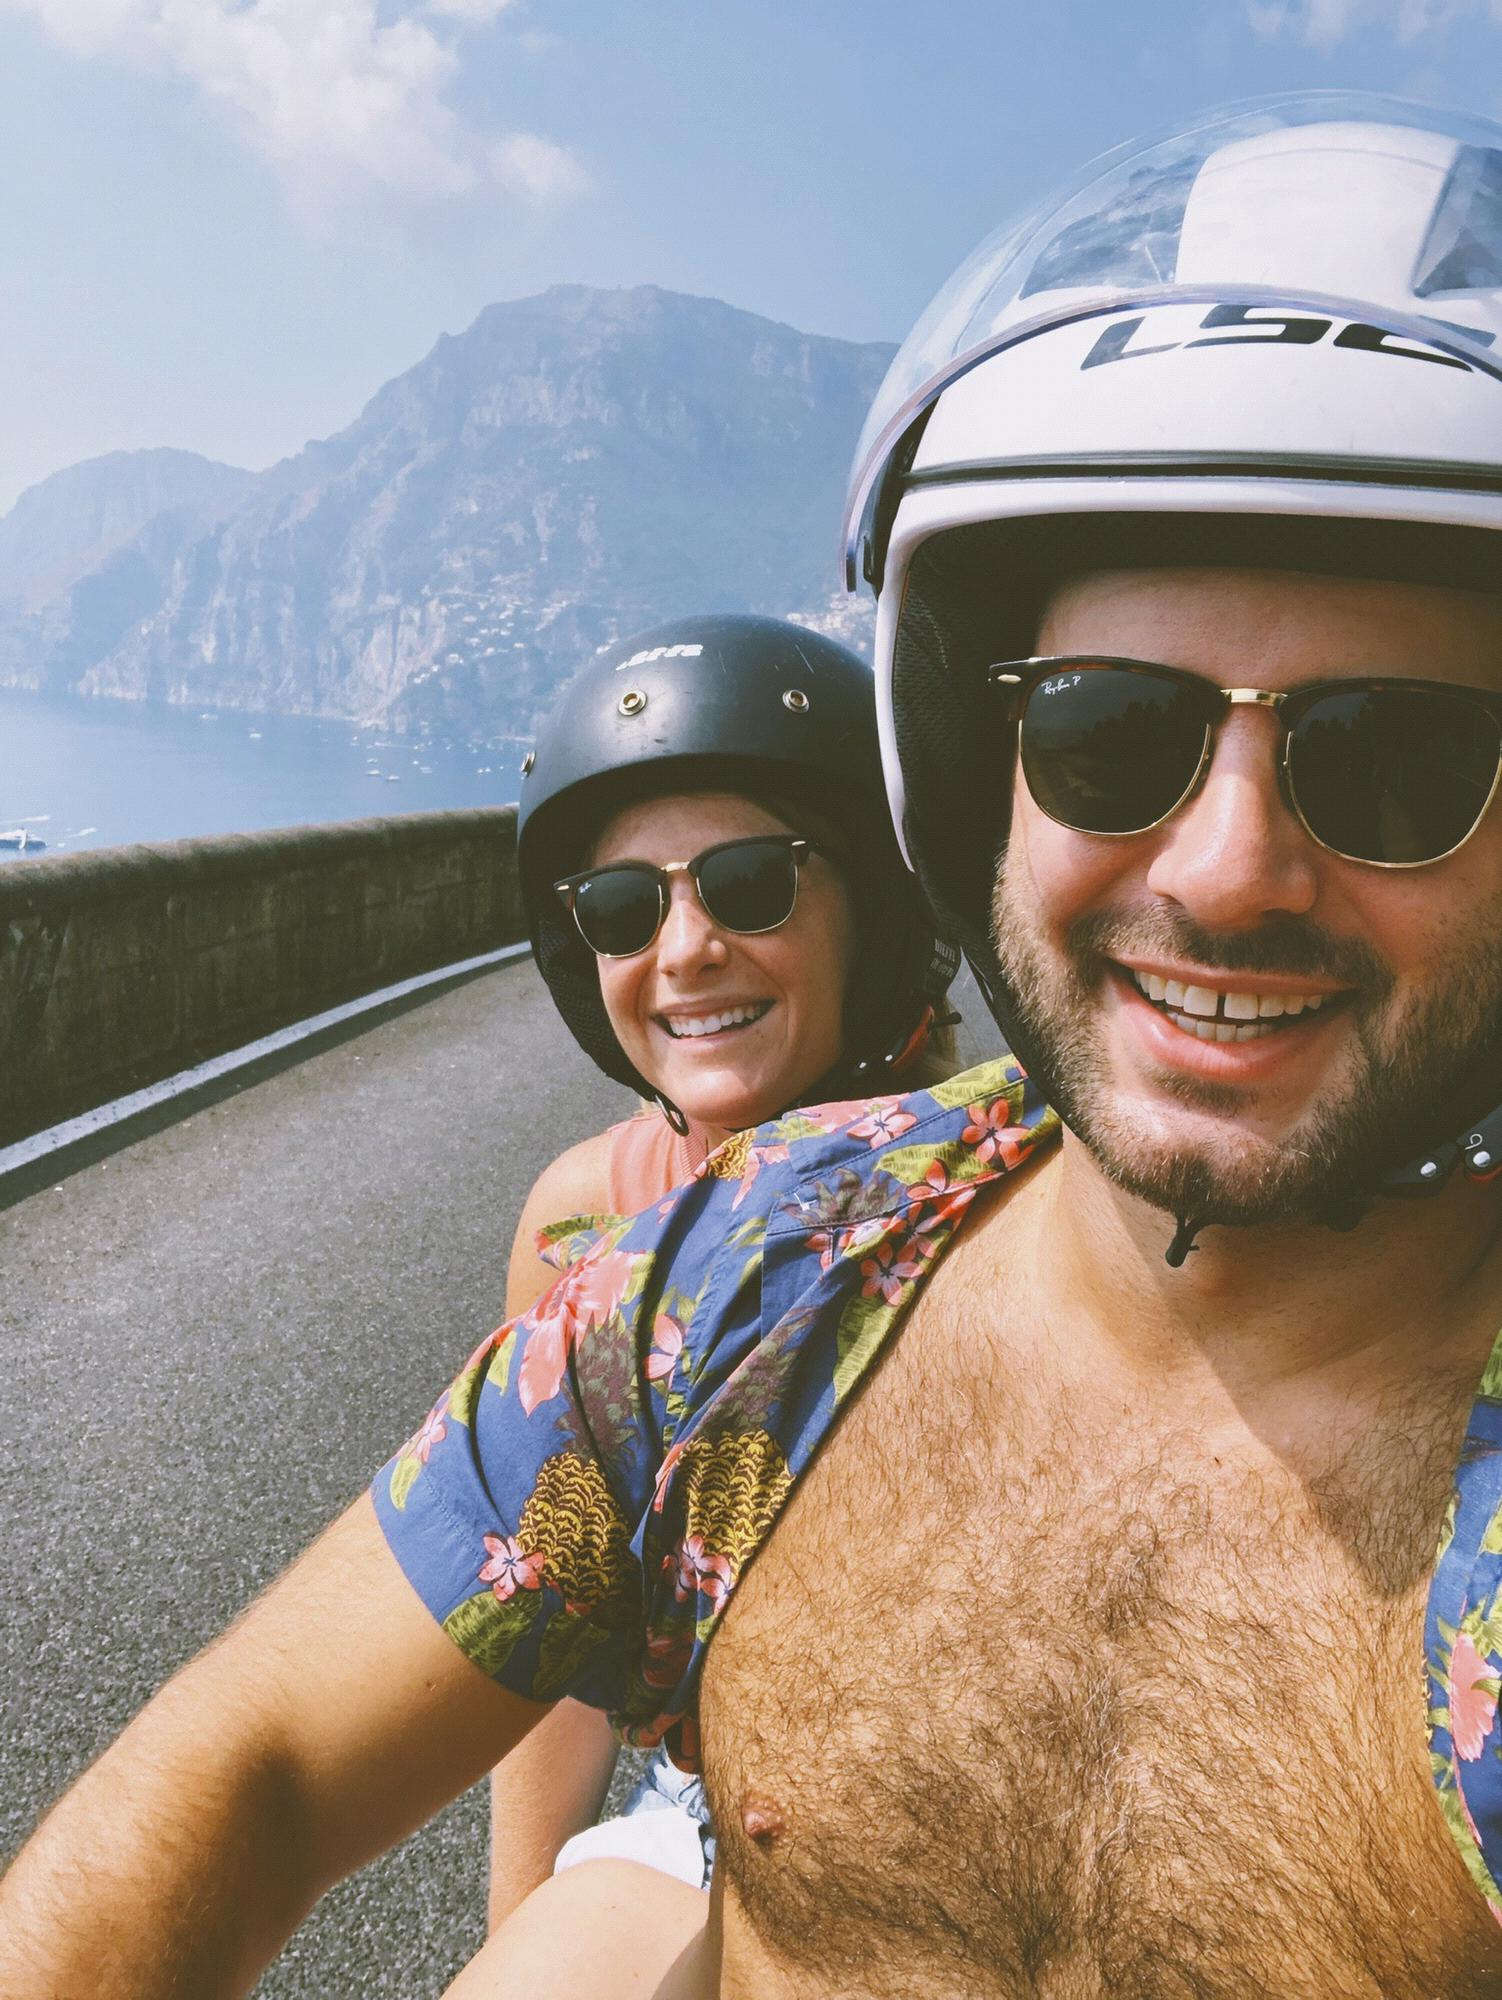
[{"xmin": 844, "ymin": 90, "xmax": 1502, "ymax": 590}]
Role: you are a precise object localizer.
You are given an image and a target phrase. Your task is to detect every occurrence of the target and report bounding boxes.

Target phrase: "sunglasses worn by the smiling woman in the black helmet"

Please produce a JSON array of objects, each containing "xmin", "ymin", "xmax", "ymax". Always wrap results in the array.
[{"xmin": 554, "ymin": 834, "xmax": 824, "ymax": 958}]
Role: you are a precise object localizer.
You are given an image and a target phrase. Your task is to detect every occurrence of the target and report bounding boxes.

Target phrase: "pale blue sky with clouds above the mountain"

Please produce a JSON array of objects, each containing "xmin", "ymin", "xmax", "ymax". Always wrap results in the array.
[{"xmin": 0, "ymin": 0, "xmax": 1502, "ymax": 510}]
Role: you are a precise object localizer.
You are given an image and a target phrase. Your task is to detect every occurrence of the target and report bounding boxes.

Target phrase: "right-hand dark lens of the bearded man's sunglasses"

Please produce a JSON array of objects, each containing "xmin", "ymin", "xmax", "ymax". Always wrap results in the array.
[{"xmin": 1288, "ymin": 686, "xmax": 1498, "ymax": 864}]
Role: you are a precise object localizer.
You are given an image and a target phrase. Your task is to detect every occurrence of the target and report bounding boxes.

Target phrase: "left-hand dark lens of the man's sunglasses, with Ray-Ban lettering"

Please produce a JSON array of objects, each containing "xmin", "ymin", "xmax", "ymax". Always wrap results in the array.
[{"xmin": 1022, "ymin": 666, "xmax": 1212, "ymax": 834}]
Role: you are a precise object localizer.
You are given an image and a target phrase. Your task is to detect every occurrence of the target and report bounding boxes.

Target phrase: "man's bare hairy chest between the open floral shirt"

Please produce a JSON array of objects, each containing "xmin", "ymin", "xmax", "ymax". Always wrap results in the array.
[{"xmin": 702, "ymin": 1272, "xmax": 1502, "ymax": 2000}]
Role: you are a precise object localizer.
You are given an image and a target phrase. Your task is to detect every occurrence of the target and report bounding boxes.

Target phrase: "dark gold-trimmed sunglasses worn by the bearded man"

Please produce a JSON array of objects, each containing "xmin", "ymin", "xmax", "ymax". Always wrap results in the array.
[{"xmin": 990, "ymin": 654, "xmax": 1502, "ymax": 868}]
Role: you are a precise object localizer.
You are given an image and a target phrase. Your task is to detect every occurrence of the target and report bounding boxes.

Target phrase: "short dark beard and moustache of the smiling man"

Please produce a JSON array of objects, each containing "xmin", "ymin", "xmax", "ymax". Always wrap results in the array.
[{"xmin": 994, "ymin": 860, "xmax": 1502, "ymax": 1224}]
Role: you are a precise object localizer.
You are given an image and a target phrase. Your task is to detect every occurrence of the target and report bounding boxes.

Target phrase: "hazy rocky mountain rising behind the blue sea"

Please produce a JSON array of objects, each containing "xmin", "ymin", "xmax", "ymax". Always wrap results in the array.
[{"xmin": 0, "ymin": 286, "xmax": 892, "ymax": 736}]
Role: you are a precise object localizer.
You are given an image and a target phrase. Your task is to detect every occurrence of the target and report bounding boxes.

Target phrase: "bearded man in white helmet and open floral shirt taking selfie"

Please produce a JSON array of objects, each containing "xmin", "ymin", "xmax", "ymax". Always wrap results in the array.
[{"xmin": 0, "ymin": 94, "xmax": 1502, "ymax": 2000}]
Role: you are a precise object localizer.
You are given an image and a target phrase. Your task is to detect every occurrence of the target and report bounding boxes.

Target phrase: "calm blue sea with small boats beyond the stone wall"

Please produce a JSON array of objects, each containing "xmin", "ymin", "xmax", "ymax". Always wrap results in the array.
[{"xmin": 0, "ymin": 688, "xmax": 526, "ymax": 866}]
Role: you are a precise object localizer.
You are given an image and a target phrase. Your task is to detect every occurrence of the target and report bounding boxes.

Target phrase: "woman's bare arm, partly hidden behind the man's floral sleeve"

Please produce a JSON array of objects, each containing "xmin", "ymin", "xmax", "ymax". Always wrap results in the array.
[{"xmin": 490, "ymin": 1132, "xmax": 616, "ymax": 1930}]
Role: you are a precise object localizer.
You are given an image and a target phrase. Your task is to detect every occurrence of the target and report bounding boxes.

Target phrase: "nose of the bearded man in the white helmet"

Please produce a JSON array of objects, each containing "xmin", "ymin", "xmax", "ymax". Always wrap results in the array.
[{"xmin": 1148, "ymin": 708, "xmax": 1318, "ymax": 930}]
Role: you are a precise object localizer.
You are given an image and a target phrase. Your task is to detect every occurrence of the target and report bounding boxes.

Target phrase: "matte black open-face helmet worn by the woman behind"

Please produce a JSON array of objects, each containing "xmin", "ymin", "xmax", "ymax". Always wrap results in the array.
[{"xmin": 516, "ymin": 612, "xmax": 958, "ymax": 1096}]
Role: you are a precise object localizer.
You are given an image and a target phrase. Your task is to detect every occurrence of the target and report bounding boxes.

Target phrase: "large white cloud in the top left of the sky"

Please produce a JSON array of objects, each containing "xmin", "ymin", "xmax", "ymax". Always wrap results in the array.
[{"xmin": 0, "ymin": 0, "xmax": 588, "ymax": 198}]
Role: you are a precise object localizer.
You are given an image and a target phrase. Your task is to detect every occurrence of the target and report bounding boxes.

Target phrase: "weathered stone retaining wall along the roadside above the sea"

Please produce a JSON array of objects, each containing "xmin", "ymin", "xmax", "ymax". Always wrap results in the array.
[{"xmin": 0, "ymin": 806, "xmax": 526, "ymax": 1146}]
